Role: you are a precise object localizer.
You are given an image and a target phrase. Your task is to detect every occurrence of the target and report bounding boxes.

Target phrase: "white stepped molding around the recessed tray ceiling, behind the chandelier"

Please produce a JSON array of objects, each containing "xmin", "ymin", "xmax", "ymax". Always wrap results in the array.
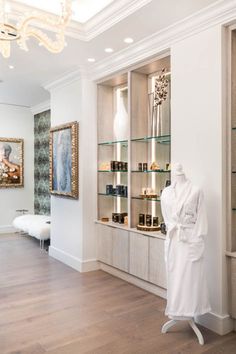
[{"xmin": 9, "ymin": 0, "xmax": 152, "ymax": 42}]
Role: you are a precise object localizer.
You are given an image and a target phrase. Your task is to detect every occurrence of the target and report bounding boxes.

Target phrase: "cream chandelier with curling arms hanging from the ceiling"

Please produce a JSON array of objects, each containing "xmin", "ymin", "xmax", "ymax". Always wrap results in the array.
[{"xmin": 0, "ymin": 0, "xmax": 72, "ymax": 58}]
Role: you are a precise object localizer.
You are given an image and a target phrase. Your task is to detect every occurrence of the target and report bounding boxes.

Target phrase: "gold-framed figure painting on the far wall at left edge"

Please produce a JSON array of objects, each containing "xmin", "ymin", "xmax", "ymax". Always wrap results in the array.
[{"xmin": 0, "ymin": 138, "xmax": 24, "ymax": 188}]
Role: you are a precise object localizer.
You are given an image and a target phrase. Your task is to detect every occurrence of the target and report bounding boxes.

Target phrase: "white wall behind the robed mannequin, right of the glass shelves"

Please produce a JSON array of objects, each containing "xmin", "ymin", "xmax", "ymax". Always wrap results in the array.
[{"xmin": 171, "ymin": 26, "xmax": 227, "ymax": 332}]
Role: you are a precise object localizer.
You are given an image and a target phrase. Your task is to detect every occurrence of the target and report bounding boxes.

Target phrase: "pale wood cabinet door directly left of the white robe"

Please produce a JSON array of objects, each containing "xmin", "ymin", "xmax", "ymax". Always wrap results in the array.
[{"xmin": 149, "ymin": 237, "xmax": 166, "ymax": 288}]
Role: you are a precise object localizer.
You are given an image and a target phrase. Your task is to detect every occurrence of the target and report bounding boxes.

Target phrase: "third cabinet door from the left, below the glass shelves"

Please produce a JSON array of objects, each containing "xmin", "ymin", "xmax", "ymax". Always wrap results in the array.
[{"xmin": 130, "ymin": 232, "xmax": 148, "ymax": 280}]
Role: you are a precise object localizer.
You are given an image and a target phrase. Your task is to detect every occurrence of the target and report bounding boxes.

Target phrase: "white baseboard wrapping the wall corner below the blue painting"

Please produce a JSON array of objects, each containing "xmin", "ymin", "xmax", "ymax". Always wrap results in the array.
[{"xmin": 49, "ymin": 246, "xmax": 100, "ymax": 273}]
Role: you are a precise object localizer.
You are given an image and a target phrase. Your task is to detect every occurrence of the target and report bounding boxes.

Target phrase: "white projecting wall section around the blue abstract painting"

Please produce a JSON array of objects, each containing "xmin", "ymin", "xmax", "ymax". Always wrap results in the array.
[{"xmin": 49, "ymin": 78, "xmax": 97, "ymax": 271}]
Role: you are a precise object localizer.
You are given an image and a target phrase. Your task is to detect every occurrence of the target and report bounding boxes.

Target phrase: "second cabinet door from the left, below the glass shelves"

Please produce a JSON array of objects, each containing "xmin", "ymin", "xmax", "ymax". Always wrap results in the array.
[{"xmin": 112, "ymin": 229, "xmax": 129, "ymax": 272}]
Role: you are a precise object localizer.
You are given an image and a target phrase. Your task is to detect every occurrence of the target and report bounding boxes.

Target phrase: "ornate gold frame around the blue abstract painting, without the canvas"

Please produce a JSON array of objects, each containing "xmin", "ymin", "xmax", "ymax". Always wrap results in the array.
[{"xmin": 50, "ymin": 122, "xmax": 79, "ymax": 199}]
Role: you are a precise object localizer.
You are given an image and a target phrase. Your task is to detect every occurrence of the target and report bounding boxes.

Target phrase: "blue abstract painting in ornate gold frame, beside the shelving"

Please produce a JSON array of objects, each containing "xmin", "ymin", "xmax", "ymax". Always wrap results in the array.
[{"xmin": 50, "ymin": 122, "xmax": 79, "ymax": 199}]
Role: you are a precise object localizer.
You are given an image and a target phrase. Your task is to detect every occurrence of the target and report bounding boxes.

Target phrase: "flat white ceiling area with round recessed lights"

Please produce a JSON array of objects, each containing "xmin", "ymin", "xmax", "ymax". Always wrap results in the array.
[{"xmin": 0, "ymin": 0, "xmax": 218, "ymax": 106}]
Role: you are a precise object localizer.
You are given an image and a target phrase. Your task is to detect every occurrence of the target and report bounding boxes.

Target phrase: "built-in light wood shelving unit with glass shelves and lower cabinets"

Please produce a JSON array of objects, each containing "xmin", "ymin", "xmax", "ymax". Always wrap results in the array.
[{"xmin": 96, "ymin": 56, "xmax": 171, "ymax": 294}]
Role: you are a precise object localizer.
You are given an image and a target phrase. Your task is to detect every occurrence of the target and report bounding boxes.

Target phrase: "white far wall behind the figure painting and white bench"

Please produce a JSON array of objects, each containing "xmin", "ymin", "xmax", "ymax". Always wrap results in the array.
[{"xmin": 0, "ymin": 104, "xmax": 34, "ymax": 232}]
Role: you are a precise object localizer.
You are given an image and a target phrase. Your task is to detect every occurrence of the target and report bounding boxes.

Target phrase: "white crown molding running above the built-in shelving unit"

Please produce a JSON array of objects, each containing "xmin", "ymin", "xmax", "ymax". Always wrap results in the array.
[{"xmin": 90, "ymin": 0, "xmax": 236, "ymax": 80}]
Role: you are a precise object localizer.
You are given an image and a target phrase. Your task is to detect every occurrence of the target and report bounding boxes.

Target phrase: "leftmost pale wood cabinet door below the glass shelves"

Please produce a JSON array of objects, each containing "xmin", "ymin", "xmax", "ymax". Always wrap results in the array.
[{"xmin": 97, "ymin": 225, "xmax": 113, "ymax": 265}]
